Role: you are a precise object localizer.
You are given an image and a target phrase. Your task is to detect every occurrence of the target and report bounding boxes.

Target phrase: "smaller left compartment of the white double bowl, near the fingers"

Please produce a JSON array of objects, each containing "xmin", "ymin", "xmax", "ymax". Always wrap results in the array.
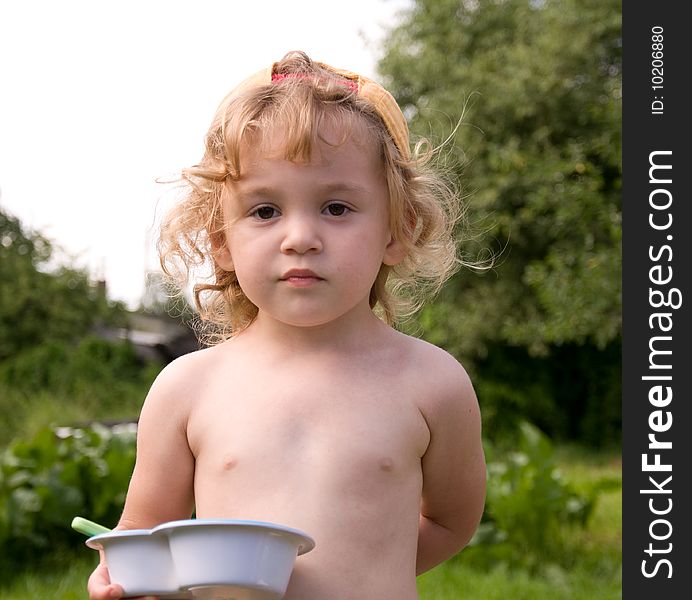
[{"xmin": 86, "ymin": 529, "xmax": 191, "ymax": 600}]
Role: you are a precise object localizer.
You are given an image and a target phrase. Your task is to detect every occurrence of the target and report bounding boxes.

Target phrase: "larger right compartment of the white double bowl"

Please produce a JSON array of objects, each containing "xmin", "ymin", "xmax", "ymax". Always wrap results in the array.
[{"xmin": 152, "ymin": 519, "xmax": 315, "ymax": 600}]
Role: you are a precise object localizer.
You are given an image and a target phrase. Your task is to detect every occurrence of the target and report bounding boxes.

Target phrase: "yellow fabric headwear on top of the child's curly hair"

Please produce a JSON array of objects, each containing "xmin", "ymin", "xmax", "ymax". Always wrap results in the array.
[{"xmin": 234, "ymin": 62, "xmax": 411, "ymax": 160}]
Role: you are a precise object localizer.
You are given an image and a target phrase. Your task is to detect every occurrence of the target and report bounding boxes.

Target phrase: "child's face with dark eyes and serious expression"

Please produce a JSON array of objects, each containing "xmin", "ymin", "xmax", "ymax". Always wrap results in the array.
[{"xmin": 215, "ymin": 120, "xmax": 403, "ymax": 326}]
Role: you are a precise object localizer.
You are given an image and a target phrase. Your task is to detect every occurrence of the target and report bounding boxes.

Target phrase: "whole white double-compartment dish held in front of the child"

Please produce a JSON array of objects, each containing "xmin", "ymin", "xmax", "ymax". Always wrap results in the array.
[{"xmin": 86, "ymin": 519, "xmax": 315, "ymax": 600}]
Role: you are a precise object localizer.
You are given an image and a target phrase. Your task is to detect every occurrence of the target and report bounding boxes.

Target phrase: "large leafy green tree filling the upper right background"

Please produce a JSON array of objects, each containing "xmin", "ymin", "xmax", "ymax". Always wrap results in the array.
[{"xmin": 379, "ymin": 0, "xmax": 622, "ymax": 359}]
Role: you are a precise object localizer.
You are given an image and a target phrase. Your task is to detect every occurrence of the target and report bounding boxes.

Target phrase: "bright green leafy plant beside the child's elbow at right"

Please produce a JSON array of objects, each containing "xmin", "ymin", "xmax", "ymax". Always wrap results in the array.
[{"xmin": 464, "ymin": 422, "xmax": 598, "ymax": 570}]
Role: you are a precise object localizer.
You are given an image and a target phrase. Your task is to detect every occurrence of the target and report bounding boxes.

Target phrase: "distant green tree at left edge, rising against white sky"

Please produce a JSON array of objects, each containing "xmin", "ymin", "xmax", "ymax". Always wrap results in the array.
[{"xmin": 0, "ymin": 209, "xmax": 125, "ymax": 362}]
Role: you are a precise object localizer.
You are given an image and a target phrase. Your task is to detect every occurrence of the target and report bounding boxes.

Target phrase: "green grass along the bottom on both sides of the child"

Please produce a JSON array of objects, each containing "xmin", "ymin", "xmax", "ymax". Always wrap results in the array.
[{"xmin": 0, "ymin": 447, "xmax": 622, "ymax": 600}]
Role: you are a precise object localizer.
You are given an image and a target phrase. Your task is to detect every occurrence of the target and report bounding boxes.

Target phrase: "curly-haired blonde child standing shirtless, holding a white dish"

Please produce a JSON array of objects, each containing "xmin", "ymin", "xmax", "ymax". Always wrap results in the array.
[{"xmin": 89, "ymin": 52, "xmax": 485, "ymax": 600}]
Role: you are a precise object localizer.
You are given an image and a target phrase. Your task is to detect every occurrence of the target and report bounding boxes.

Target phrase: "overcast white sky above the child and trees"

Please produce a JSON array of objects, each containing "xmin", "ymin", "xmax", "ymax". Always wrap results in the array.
[{"xmin": 0, "ymin": 0, "xmax": 407, "ymax": 306}]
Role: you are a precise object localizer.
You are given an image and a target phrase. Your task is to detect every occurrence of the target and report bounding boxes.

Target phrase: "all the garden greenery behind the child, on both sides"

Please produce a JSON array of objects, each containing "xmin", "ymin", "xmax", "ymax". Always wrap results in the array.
[{"xmin": 0, "ymin": 0, "xmax": 622, "ymax": 600}]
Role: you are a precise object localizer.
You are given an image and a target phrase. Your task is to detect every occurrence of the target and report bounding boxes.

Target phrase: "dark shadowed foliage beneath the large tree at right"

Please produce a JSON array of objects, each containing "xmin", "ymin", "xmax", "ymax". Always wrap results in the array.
[{"xmin": 474, "ymin": 340, "xmax": 622, "ymax": 447}]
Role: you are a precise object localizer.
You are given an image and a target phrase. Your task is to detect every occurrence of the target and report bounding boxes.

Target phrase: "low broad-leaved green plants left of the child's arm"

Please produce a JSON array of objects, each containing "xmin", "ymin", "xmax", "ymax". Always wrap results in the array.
[{"xmin": 0, "ymin": 425, "xmax": 135, "ymax": 573}]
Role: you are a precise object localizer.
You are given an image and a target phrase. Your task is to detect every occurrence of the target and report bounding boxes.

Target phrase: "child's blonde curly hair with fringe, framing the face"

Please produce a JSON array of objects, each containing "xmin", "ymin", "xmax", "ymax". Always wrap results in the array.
[{"xmin": 157, "ymin": 52, "xmax": 461, "ymax": 343}]
